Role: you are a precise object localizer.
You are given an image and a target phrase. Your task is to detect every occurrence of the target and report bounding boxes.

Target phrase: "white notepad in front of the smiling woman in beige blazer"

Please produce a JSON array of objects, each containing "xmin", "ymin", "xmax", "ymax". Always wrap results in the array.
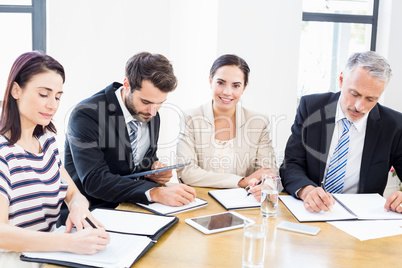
[{"xmin": 208, "ymin": 188, "xmax": 261, "ymax": 210}]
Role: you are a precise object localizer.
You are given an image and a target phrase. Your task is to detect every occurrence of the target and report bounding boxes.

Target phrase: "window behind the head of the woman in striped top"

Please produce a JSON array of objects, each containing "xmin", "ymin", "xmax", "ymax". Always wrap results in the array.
[{"xmin": 0, "ymin": 0, "xmax": 46, "ymax": 99}]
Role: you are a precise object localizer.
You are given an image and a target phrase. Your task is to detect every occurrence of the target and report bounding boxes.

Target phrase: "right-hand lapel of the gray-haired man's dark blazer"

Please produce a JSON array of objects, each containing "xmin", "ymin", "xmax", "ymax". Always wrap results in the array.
[{"xmin": 359, "ymin": 104, "xmax": 382, "ymax": 193}]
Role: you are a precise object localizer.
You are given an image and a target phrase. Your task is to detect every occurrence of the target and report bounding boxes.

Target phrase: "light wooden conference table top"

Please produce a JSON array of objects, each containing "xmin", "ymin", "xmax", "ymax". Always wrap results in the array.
[{"xmin": 46, "ymin": 187, "xmax": 402, "ymax": 268}]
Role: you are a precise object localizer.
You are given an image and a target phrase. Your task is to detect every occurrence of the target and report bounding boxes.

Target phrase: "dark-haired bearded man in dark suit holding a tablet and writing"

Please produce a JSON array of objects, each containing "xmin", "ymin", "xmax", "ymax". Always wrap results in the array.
[{"xmin": 65, "ymin": 52, "xmax": 196, "ymax": 208}]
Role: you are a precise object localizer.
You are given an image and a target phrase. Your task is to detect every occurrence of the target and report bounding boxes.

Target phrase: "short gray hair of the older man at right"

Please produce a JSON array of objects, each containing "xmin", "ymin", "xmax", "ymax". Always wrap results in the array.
[{"xmin": 343, "ymin": 51, "xmax": 392, "ymax": 83}]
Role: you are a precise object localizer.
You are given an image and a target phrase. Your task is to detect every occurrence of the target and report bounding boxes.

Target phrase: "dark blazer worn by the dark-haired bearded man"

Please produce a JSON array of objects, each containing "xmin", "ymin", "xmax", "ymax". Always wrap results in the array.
[{"xmin": 65, "ymin": 83, "xmax": 160, "ymax": 208}]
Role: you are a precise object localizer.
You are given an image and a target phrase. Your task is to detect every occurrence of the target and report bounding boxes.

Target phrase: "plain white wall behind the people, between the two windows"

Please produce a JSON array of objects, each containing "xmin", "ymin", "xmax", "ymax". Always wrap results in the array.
[{"xmin": 47, "ymin": 0, "xmax": 302, "ymax": 169}]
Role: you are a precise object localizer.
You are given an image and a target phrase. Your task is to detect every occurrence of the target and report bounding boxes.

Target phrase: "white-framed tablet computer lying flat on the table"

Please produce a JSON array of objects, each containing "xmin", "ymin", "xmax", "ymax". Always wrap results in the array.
[{"xmin": 184, "ymin": 211, "xmax": 247, "ymax": 234}]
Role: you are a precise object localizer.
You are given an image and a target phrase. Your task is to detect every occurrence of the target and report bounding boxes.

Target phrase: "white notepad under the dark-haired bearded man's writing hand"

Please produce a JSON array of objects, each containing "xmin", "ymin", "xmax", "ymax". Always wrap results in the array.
[{"xmin": 136, "ymin": 197, "xmax": 208, "ymax": 215}]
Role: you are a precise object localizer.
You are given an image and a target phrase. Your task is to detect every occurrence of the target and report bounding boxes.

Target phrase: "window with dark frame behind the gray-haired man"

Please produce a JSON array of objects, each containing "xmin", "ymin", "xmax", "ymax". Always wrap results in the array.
[{"xmin": 298, "ymin": 0, "xmax": 379, "ymax": 99}]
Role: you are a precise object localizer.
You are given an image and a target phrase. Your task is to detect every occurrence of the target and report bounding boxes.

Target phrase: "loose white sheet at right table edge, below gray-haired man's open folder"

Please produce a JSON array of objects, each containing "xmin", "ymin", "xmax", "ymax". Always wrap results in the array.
[{"xmin": 328, "ymin": 220, "xmax": 402, "ymax": 241}]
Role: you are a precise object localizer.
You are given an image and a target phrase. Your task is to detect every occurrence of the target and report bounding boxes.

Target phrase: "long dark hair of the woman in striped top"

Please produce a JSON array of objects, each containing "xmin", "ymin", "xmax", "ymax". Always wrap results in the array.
[{"xmin": 0, "ymin": 51, "xmax": 65, "ymax": 144}]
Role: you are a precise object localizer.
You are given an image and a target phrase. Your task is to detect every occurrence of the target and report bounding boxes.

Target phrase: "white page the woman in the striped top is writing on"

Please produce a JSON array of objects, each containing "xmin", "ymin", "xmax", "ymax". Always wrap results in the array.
[{"xmin": 23, "ymin": 226, "xmax": 151, "ymax": 267}]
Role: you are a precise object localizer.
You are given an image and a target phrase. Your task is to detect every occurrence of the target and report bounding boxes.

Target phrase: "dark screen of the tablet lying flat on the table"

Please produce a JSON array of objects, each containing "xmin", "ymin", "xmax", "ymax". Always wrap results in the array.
[{"xmin": 191, "ymin": 212, "xmax": 244, "ymax": 231}]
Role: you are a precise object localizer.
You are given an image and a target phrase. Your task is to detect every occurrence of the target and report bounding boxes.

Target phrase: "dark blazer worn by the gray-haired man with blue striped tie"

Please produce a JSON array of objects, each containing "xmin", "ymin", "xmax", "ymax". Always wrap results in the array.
[{"xmin": 280, "ymin": 92, "xmax": 402, "ymax": 196}]
